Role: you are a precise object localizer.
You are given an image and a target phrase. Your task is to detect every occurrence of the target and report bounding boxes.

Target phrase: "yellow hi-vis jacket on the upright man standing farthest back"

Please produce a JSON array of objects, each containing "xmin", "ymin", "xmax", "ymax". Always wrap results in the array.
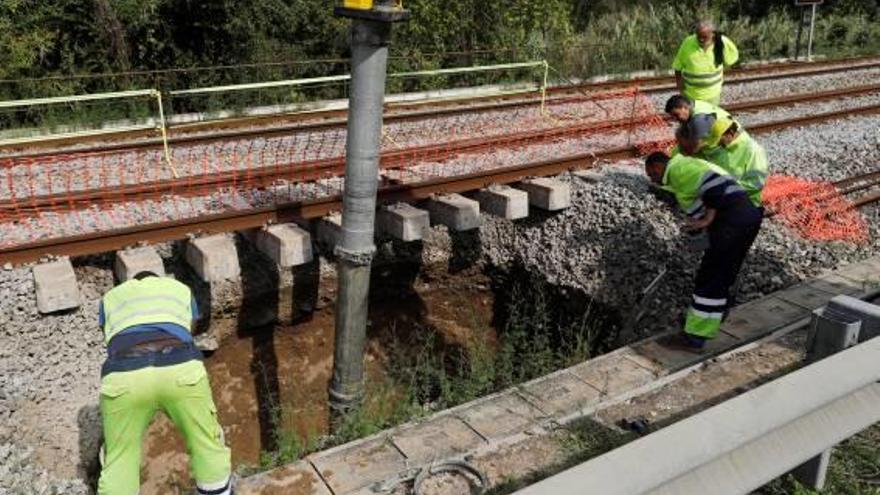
[{"xmin": 672, "ymin": 34, "xmax": 739, "ymax": 105}]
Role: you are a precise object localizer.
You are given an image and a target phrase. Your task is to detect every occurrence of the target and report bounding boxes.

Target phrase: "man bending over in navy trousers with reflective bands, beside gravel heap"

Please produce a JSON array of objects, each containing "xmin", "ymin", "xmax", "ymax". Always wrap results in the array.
[{"xmin": 645, "ymin": 152, "xmax": 763, "ymax": 351}]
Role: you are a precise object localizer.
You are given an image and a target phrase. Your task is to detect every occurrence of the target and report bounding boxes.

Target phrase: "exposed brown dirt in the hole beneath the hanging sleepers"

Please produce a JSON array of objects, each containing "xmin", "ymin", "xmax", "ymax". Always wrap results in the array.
[{"xmin": 141, "ymin": 280, "xmax": 494, "ymax": 495}]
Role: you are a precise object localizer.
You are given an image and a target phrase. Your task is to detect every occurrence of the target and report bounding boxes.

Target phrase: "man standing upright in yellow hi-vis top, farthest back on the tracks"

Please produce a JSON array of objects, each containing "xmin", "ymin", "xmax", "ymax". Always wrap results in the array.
[{"xmin": 672, "ymin": 22, "xmax": 739, "ymax": 105}]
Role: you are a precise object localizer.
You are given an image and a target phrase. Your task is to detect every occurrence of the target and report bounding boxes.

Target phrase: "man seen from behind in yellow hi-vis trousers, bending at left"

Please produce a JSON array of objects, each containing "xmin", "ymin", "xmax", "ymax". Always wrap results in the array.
[{"xmin": 98, "ymin": 272, "xmax": 233, "ymax": 495}]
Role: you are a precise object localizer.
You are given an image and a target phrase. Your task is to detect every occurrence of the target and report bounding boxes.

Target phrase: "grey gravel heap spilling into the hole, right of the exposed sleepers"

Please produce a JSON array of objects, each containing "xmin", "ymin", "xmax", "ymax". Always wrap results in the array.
[{"xmin": 481, "ymin": 166, "xmax": 699, "ymax": 334}]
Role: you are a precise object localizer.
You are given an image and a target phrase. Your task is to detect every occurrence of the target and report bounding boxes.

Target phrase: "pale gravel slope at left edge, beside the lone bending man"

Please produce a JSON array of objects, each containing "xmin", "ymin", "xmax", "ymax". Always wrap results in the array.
[{"xmin": 0, "ymin": 259, "xmax": 112, "ymax": 493}]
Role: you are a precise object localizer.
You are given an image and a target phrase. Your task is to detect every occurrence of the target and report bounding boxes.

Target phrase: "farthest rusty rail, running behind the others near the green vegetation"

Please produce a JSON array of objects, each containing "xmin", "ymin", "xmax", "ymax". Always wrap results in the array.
[{"xmin": 6, "ymin": 57, "xmax": 880, "ymax": 157}]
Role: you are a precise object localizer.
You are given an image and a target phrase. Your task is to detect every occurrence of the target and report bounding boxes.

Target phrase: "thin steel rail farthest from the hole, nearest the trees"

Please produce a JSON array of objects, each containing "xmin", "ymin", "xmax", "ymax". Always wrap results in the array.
[{"xmin": 6, "ymin": 57, "xmax": 880, "ymax": 156}]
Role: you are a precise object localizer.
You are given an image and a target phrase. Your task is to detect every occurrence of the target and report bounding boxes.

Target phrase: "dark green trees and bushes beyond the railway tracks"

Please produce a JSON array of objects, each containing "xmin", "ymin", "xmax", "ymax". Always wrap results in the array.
[{"xmin": 0, "ymin": 0, "xmax": 878, "ymax": 97}]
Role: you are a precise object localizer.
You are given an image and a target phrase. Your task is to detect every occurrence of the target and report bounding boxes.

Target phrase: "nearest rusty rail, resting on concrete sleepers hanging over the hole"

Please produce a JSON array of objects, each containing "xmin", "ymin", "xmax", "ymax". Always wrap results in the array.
[{"xmin": 0, "ymin": 98, "xmax": 880, "ymax": 264}]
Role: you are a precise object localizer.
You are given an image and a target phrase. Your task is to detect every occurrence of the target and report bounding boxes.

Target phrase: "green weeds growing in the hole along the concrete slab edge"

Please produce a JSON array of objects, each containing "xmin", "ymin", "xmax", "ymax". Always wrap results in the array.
[{"xmin": 251, "ymin": 272, "xmax": 615, "ymax": 468}]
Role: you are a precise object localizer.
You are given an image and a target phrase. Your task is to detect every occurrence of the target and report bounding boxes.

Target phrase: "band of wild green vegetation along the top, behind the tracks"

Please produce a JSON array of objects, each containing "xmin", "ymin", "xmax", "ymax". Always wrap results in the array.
[{"xmin": 0, "ymin": 0, "xmax": 880, "ymax": 132}]
